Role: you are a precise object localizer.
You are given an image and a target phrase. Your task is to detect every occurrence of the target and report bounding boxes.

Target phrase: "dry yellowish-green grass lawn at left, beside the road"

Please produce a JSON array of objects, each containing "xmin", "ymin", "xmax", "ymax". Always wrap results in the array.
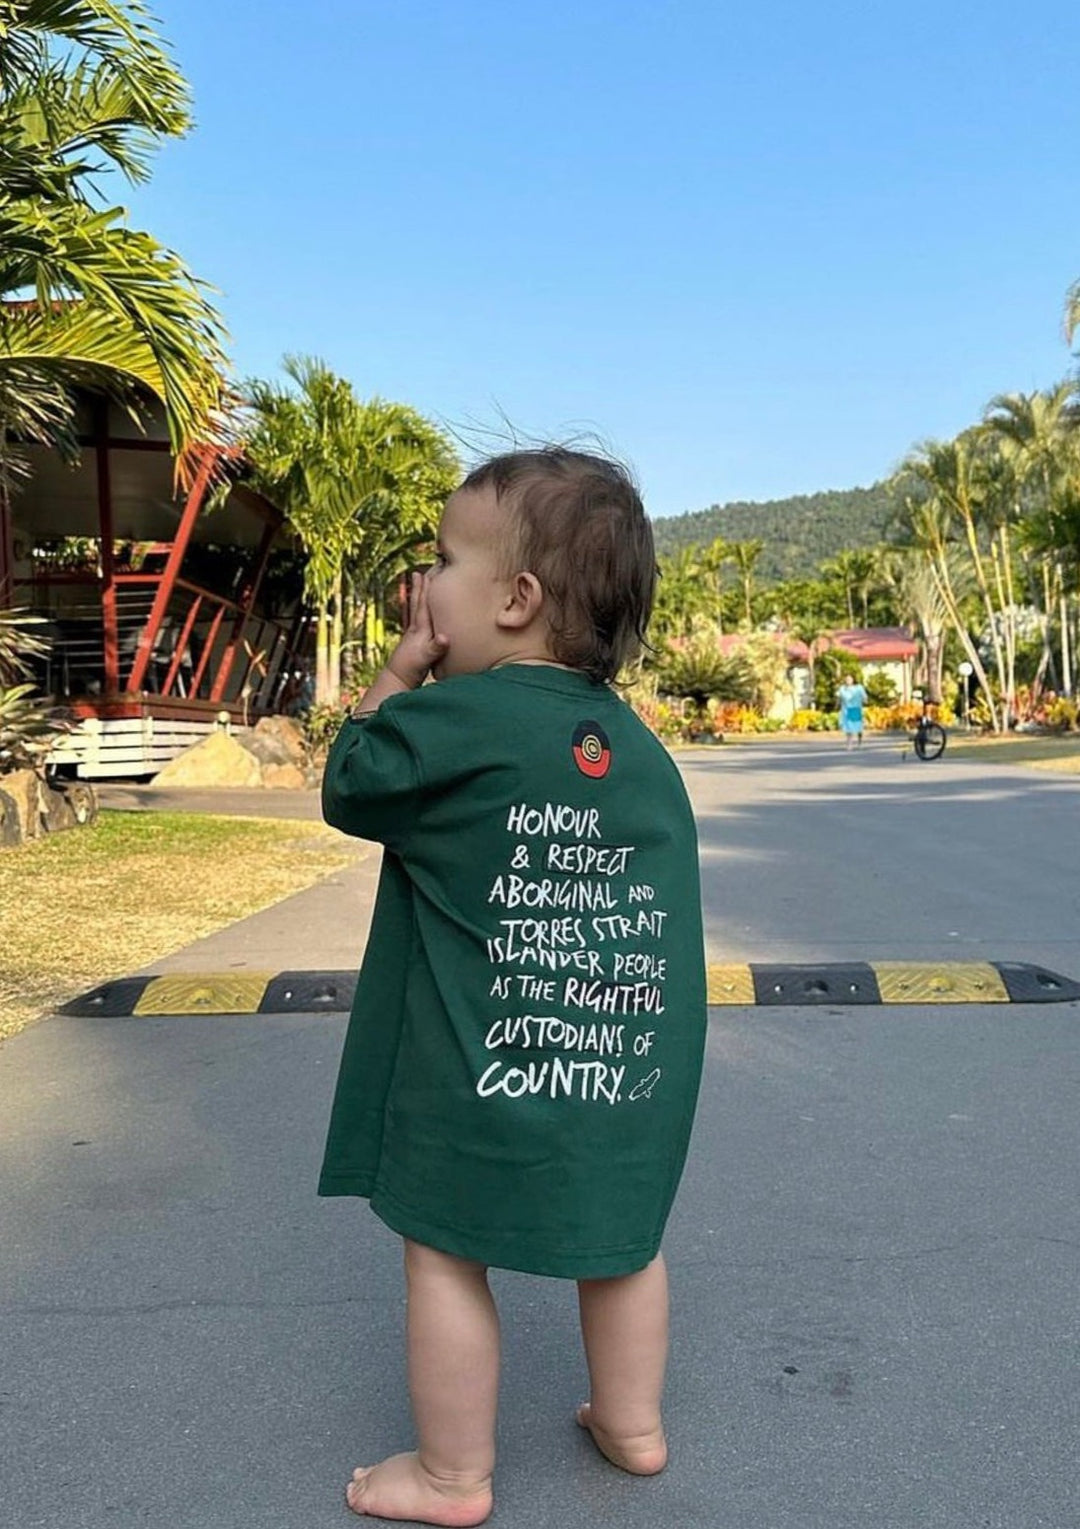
[{"xmin": 0, "ymin": 812, "xmax": 358, "ymax": 1038}]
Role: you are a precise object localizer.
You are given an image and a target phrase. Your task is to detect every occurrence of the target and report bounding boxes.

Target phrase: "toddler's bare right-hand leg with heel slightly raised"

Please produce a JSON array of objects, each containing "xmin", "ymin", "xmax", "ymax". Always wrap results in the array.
[{"xmin": 578, "ymin": 1255, "xmax": 667, "ymax": 1475}]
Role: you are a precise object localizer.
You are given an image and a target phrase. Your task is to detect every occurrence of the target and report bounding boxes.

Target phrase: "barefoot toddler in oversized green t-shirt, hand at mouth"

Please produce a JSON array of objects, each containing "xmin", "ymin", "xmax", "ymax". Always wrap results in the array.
[{"xmin": 320, "ymin": 448, "xmax": 707, "ymax": 1526}]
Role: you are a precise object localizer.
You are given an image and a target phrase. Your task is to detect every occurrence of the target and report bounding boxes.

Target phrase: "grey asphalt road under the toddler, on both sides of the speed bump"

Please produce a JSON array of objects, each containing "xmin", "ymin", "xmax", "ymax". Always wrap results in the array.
[{"xmin": 0, "ymin": 745, "xmax": 1080, "ymax": 1529}]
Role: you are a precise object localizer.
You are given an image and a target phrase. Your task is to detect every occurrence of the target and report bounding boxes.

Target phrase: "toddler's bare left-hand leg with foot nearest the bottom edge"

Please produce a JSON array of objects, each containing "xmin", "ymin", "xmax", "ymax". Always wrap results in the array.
[{"xmin": 346, "ymin": 1240, "xmax": 499, "ymax": 1526}]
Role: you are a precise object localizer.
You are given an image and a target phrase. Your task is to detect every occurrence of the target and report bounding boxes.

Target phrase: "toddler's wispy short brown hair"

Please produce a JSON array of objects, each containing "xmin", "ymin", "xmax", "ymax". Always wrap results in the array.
[{"xmin": 462, "ymin": 446, "xmax": 656, "ymax": 683}]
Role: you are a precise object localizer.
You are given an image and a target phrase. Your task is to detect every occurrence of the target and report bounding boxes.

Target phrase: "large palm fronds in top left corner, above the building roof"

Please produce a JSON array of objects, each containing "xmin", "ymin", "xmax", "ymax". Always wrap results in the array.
[{"xmin": 0, "ymin": 0, "xmax": 225, "ymax": 468}]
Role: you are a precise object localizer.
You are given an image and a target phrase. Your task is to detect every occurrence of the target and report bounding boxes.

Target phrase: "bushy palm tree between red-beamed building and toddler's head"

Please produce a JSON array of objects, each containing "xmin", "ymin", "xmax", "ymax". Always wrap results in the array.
[{"xmin": 246, "ymin": 356, "xmax": 460, "ymax": 705}]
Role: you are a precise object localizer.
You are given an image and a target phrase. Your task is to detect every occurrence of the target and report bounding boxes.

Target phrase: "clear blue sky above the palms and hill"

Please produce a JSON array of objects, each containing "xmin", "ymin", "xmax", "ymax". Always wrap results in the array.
[{"xmin": 128, "ymin": 0, "xmax": 1080, "ymax": 514}]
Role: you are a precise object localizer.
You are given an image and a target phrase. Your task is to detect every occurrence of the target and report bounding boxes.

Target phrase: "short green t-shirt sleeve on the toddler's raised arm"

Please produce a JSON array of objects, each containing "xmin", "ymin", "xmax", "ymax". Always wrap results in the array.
[{"xmin": 323, "ymin": 705, "xmax": 421, "ymax": 849}]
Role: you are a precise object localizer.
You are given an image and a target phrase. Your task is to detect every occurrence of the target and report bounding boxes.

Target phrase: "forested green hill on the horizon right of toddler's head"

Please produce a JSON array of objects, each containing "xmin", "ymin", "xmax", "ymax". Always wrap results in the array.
[{"xmin": 653, "ymin": 483, "xmax": 895, "ymax": 584}]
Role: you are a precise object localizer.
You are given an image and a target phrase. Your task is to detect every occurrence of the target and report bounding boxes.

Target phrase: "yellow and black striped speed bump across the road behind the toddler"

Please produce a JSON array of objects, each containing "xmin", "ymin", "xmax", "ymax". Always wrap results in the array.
[{"xmin": 60, "ymin": 960, "xmax": 1080, "ymax": 1018}]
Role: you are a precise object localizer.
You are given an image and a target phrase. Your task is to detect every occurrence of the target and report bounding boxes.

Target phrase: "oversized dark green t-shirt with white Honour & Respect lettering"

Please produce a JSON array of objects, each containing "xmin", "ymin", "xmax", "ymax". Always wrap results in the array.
[{"xmin": 320, "ymin": 664, "xmax": 705, "ymax": 1278}]
